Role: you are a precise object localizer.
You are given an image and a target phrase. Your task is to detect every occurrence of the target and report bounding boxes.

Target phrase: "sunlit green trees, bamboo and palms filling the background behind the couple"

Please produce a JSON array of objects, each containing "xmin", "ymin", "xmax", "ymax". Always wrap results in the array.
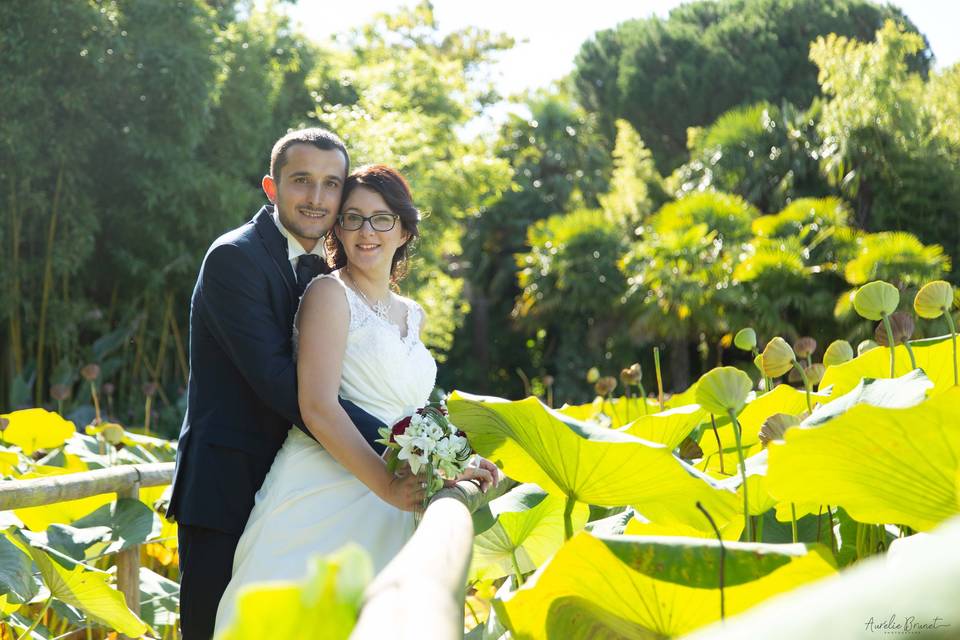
[{"xmin": 0, "ymin": 0, "xmax": 960, "ymax": 435}]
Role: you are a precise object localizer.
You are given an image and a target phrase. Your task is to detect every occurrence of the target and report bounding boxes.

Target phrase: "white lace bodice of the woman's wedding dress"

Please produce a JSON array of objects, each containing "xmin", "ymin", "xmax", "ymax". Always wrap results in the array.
[{"xmin": 293, "ymin": 273, "xmax": 437, "ymax": 424}]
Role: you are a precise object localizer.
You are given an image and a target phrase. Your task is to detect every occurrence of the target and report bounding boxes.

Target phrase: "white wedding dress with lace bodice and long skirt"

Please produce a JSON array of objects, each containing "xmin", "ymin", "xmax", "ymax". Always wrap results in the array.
[{"xmin": 216, "ymin": 274, "xmax": 437, "ymax": 632}]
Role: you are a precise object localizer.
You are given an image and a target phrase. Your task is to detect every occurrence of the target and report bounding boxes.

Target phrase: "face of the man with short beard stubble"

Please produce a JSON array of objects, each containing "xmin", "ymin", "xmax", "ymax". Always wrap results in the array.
[{"xmin": 263, "ymin": 144, "xmax": 347, "ymax": 251}]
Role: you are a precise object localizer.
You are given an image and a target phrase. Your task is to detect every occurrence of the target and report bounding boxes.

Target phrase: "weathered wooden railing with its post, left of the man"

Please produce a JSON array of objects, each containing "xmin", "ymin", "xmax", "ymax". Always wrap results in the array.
[{"xmin": 0, "ymin": 462, "xmax": 173, "ymax": 632}]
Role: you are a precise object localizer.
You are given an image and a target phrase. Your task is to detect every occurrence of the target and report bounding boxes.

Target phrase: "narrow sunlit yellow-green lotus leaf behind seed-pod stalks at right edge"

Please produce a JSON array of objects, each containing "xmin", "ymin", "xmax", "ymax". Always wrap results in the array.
[{"xmin": 819, "ymin": 336, "xmax": 953, "ymax": 398}]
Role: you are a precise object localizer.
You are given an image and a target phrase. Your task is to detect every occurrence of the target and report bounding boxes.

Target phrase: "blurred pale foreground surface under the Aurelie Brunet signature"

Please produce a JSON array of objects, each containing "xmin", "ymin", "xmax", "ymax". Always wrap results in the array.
[{"xmin": 685, "ymin": 519, "xmax": 960, "ymax": 640}]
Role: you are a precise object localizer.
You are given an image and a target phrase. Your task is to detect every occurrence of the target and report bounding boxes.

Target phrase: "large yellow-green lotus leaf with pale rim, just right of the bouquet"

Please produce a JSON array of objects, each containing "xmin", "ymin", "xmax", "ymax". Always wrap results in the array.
[{"xmin": 447, "ymin": 391, "xmax": 737, "ymax": 528}]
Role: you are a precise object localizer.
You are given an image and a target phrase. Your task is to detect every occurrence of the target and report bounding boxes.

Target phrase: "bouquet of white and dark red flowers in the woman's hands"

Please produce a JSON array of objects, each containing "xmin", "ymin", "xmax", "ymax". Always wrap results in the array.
[{"xmin": 377, "ymin": 402, "xmax": 473, "ymax": 497}]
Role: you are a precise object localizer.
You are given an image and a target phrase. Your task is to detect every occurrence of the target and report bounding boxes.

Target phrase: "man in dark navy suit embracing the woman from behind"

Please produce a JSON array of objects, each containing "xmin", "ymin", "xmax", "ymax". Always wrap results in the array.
[{"xmin": 168, "ymin": 129, "xmax": 382, "ymax": 640}]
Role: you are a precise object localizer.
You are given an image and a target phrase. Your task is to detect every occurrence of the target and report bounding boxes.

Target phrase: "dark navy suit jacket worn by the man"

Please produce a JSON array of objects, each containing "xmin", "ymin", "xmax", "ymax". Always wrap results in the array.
[{"xmin": 167, "ymin": 206, "xmax": 382, "ymax": 534}]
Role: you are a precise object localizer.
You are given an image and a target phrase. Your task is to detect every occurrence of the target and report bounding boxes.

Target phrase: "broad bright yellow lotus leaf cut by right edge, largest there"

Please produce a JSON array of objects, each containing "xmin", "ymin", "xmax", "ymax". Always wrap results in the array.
[{"xmin": 767, "ymin": 387, "xmax": 960, "ymax": 531}]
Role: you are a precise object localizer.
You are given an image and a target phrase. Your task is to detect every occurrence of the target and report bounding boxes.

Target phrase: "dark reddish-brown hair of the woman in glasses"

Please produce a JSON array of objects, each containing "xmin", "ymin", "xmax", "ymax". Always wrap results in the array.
[{"xmin": 326, "ymin": 164, "xmax": 420, "ymax": 283}]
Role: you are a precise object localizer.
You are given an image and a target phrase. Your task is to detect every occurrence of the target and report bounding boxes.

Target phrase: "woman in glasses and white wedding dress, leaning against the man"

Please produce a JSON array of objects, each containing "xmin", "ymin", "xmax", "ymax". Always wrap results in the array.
[{"xmin": 216, "ymin": 165, "xmax": 495, "ymax": 633}]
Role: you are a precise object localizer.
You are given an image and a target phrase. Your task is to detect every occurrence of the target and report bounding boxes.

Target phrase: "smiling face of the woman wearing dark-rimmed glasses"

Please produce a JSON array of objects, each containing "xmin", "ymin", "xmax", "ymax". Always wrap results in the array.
[{"xmin": 334, "ymin": 187, "xmax": 409, "ymax": 273}]
